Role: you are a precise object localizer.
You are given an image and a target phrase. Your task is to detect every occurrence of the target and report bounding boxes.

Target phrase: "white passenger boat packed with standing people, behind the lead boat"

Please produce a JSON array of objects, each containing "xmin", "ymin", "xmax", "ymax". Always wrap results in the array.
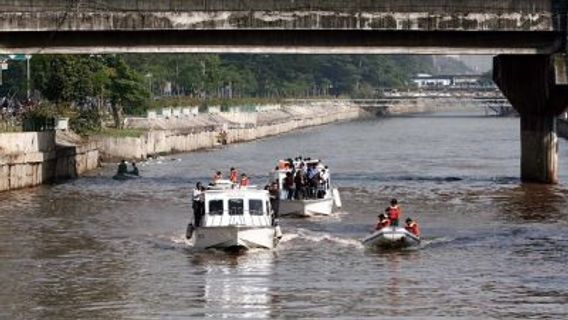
[{"xmin": 272, "ymin": 159, "xmax": 341, "ymax": 217}]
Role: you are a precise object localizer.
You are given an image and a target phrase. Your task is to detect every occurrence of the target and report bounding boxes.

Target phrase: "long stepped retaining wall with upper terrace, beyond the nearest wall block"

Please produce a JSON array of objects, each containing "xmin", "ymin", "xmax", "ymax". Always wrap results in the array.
[{"xmin": 97, "ymin": 102, "xmax": 369, "ymax": 161}]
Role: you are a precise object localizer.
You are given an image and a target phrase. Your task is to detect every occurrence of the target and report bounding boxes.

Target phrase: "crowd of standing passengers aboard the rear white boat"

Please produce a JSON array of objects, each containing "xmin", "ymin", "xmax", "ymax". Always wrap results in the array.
[{"xmin": 276, "ymin": 157, "xmax": 329, "ymax": 200}]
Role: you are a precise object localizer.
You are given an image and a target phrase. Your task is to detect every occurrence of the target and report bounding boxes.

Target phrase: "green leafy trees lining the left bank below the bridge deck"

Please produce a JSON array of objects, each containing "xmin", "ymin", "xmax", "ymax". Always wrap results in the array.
[{"xmin": 0, "ymin": 54, "xmax": 470, "ymax": 131}]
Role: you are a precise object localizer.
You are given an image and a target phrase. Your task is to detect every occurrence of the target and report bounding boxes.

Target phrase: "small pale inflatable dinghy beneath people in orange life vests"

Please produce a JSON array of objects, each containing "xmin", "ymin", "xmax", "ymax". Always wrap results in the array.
[{"xmin": 362, "ymin": 227, "xmax": 420, "ymax": 248}]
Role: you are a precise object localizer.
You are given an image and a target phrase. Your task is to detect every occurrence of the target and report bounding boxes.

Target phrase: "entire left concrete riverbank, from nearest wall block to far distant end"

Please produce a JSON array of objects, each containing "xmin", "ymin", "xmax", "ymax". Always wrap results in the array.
[{"xmin": 0, "ymin": 98, "xmax": 488, "ymax": 191}]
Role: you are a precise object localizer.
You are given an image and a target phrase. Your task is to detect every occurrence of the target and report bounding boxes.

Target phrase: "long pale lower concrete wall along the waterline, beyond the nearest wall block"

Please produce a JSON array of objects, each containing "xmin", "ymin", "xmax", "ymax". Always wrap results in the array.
[{"xmin": 97, "ymin": 106, "xmax": 368, "ymax": 160}]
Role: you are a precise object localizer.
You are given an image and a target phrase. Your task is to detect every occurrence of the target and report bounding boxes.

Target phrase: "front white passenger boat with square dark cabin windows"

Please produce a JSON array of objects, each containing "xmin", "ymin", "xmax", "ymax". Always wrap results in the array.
[{"xmin": 186, "ymin": 180, "xmax": 282, "ymax": 250}]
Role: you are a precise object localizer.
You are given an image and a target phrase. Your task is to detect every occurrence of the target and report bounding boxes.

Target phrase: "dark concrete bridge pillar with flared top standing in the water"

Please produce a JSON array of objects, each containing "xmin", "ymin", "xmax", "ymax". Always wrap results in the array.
[{"xmin": 493, "ymin": 55, "xmax": 568, "ymax": 184}]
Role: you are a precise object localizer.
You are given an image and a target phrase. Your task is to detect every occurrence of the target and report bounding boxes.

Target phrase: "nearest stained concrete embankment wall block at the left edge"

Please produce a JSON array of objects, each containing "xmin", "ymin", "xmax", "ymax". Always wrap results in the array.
[{"xmin": 0, "ymin": 131, "xmax": 99, "ymax": 191}]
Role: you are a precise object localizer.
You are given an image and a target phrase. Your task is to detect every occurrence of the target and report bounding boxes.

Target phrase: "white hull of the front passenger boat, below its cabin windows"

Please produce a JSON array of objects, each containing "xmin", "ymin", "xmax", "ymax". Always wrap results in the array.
[{"xmin": 193, "ymin": 226, "xmax": 278, "ymax": 249}]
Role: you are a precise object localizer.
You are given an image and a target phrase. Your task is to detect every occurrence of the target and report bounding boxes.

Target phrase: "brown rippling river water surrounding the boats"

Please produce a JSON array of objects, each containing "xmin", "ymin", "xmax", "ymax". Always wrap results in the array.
[{"xmin": 0, "ymin": 112, "xmax": 568, "ymax": 320}]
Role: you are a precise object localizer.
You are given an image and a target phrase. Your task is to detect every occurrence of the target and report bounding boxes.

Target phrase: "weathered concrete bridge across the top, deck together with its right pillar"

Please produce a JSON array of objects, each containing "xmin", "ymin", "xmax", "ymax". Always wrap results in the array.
[{"xmin": 0, "ymin": 0, "xmax": 568, "ymax": 183}]
